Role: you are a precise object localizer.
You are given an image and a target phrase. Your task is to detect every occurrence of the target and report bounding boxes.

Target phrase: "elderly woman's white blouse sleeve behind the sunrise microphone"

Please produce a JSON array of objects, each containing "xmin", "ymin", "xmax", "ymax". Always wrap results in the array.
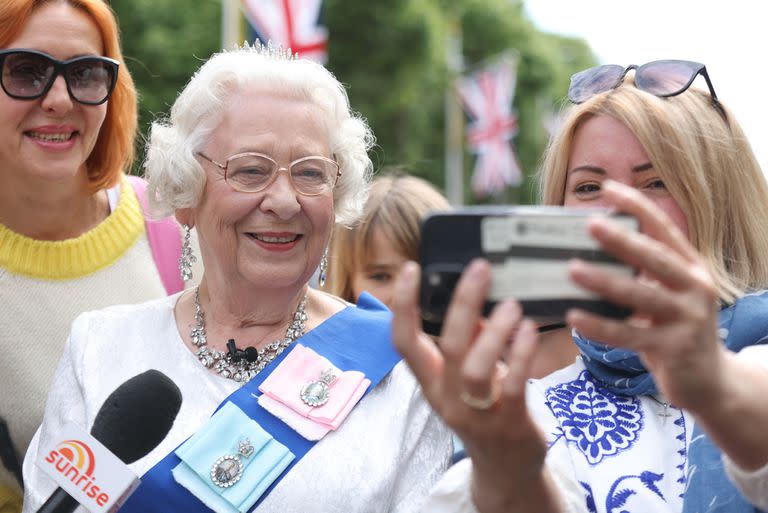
[{"xmin": 23, "ymin": 314, "xmax": 89, "ymax": 513}]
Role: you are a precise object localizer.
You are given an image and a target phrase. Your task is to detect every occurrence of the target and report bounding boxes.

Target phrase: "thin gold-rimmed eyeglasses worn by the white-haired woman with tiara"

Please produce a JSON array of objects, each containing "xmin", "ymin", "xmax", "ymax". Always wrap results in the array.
[{"xmin": 198, "ymin": 152, "xmax": 341, "ymax": 196}]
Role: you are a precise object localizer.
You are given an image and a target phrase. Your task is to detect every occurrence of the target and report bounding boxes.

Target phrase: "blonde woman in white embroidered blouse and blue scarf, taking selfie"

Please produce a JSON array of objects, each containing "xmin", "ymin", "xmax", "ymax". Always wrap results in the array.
[{"xmin": 392, "ymin": 61, "xmax": 768, "ymax": 513}]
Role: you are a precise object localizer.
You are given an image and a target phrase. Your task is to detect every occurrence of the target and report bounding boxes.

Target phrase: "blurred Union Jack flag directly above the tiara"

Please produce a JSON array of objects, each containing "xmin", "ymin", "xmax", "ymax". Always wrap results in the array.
[{"xmin": 242, "ymin": 0, "xmax": 328, "ymax": 64}]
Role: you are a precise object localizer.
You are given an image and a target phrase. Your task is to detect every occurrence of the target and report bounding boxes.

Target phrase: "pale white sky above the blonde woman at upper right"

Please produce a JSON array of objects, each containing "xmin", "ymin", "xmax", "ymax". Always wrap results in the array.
[{"xmin": 525, "ymin": 0, "xmax": 768, "ymax": 174}]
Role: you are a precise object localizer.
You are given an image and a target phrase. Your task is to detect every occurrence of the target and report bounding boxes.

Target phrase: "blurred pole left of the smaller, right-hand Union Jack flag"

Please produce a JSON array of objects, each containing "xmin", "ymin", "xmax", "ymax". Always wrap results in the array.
[{"xmin": 445, "ymin": 15, "xmax": 464, "ymax": 206}]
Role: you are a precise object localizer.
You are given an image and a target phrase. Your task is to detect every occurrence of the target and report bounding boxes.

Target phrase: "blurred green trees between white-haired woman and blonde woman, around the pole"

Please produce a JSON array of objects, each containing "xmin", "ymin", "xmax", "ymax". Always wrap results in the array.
[{"xmin": 326, "ymin": 0, "xmax": 594, "ymax": 203}]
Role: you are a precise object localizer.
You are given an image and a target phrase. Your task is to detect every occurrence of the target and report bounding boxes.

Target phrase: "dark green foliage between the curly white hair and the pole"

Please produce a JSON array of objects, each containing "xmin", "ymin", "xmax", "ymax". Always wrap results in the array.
[{"xmin": 325, "ymin": 0, "xmax": 445, "ymax": 178}]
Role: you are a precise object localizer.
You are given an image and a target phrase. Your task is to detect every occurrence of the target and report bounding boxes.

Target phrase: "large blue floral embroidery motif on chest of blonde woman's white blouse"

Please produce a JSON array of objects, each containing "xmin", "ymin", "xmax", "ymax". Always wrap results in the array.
[{"xmin": 546, "ymin": 371, "xmax": 643, "ymax": 465}]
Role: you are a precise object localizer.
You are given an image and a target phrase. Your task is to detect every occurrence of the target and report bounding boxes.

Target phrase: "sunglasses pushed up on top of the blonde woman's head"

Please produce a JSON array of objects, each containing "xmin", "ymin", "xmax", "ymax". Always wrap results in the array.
[{"xmin": 568, "ymin": 60, "xmax": 722, "ymax": 110}]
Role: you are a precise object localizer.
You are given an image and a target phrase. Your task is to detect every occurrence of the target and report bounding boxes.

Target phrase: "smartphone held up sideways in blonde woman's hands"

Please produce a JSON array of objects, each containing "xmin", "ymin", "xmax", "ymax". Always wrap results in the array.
[{"xmin": 420, "ymin": 206, "xmax": 638, "ymax": 335}]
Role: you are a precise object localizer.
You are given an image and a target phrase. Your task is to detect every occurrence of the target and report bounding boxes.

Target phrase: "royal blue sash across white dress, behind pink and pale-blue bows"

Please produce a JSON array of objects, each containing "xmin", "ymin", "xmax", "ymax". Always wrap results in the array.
[{"xmin": 120, "ymin": 293, "xmax": 401, "ymax": 513}]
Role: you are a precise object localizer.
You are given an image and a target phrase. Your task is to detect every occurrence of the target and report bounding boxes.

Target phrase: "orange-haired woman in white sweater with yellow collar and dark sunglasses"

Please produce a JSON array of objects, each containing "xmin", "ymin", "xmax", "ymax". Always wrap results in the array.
[{"xmin": 0, "ymin": 0, "xmax": 191, "ymax": 511}]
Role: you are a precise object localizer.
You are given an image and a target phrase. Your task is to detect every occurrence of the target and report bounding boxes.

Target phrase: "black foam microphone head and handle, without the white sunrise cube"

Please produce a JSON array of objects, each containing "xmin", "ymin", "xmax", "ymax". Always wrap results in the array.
[{"xmin": 37, "ymin": 369, "xmax": 181, "ymax": 513}]
